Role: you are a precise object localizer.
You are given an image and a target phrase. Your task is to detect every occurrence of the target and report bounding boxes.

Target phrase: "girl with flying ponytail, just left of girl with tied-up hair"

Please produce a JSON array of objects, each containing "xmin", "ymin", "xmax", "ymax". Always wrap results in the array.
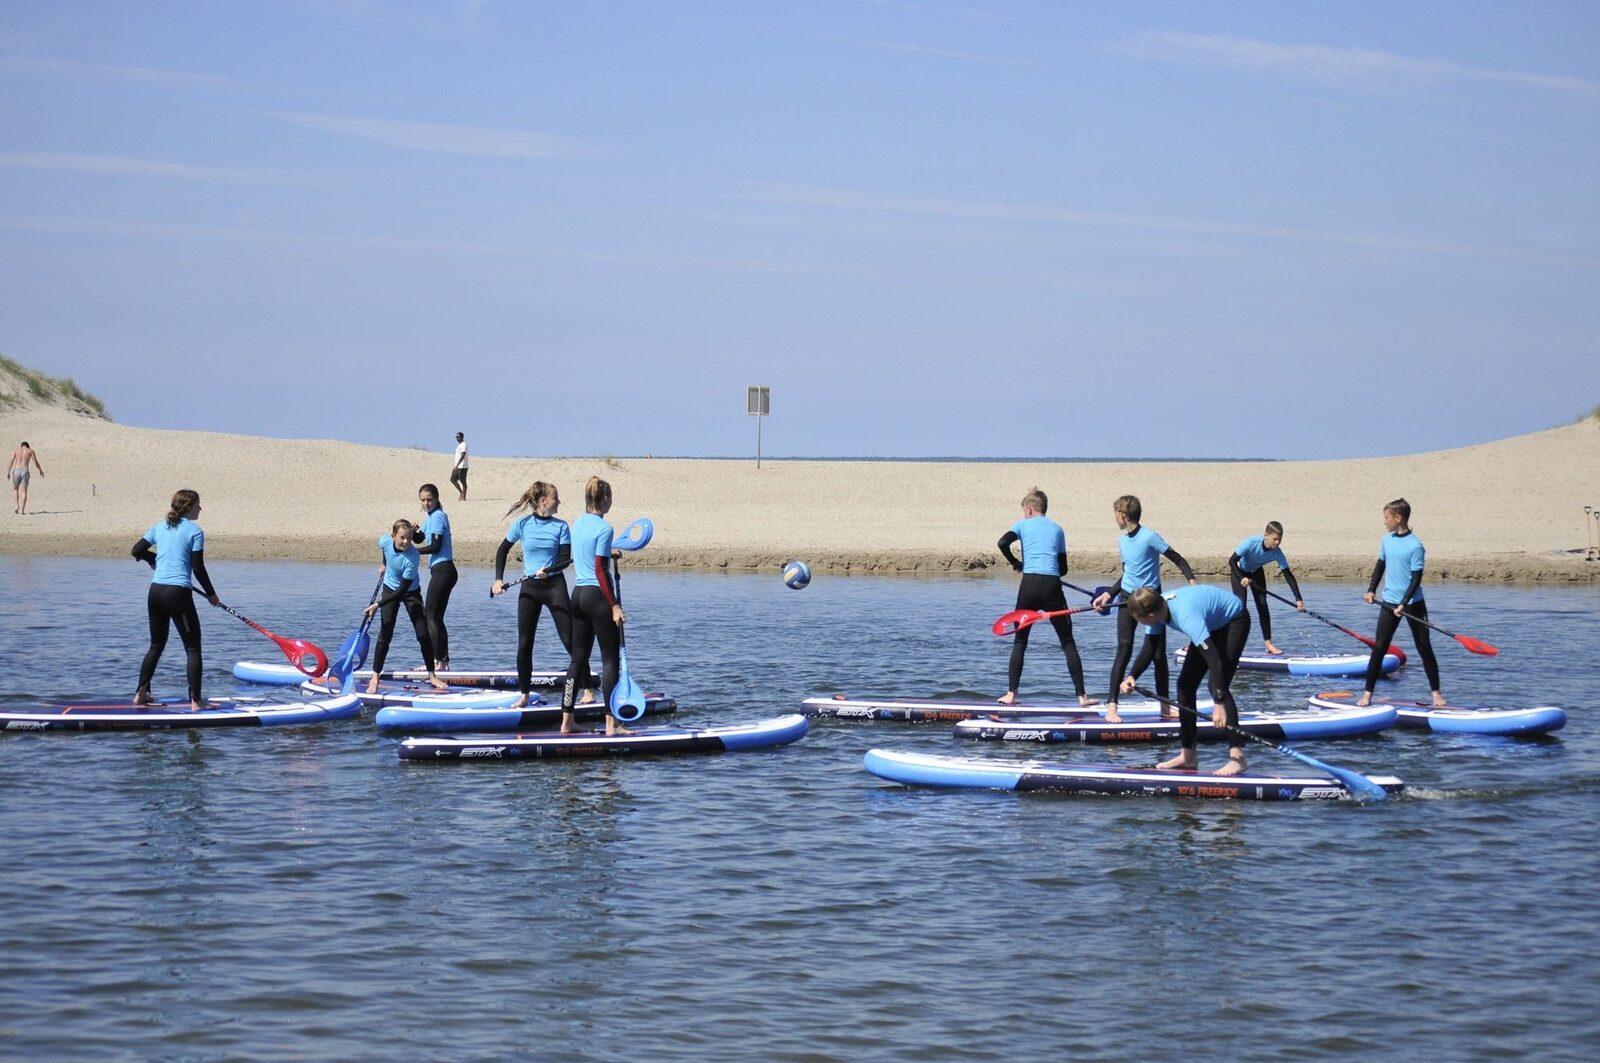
[{"xmin": 490, "ymin": 480, "xmax": 594, "ymax": 709}]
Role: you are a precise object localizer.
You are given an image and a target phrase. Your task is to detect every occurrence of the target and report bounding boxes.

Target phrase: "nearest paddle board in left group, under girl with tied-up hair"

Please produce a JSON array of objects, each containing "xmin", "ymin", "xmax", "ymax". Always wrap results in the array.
[{"xmin": 400, "ymin": 712, "xmax": 806, "ymax": 764}]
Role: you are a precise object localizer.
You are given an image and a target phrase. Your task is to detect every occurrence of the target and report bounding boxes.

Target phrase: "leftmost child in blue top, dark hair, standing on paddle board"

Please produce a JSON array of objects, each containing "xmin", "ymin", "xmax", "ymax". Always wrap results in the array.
[{"xmin": 132, "ymin": 493, "xmax": 222, "ymax": 712}]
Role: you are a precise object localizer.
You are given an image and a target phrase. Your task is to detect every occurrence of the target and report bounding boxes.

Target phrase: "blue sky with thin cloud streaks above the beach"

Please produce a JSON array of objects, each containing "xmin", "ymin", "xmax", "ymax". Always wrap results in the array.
[{"xmin": 0, "ymin": 0, "xmax": 1600, "ymax": 458}]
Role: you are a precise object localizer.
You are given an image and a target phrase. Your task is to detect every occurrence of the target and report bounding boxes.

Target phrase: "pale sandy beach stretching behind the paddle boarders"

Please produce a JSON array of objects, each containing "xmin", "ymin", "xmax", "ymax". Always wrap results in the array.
[{"xmin": 0, "ymin": 407, "xmax": 1600, "ymax": 583}]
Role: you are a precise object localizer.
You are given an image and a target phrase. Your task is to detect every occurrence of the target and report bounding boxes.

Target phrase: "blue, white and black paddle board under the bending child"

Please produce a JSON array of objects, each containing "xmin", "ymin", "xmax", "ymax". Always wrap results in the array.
[{"xmin": 862, "ymin": 749, "xmax": 1405, "ymax": 800}]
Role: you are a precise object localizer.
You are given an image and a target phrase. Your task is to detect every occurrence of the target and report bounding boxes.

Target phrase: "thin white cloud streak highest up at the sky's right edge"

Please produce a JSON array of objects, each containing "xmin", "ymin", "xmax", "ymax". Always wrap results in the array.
[{"xmin": 1107, "ymin": 32, "xmax": 1600, "ymax": 98}]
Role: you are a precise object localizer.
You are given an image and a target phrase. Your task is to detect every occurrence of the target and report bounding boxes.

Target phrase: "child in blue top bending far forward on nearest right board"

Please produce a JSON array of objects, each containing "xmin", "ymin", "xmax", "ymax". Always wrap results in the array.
[{"xmin": 1122, "ymin": 586, "xmax": 1250, "ymax": 775}]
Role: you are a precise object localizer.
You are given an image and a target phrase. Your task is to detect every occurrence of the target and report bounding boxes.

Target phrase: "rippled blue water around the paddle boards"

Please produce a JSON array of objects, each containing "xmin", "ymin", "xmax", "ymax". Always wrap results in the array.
[{"xmin": 0, "ymin": 557, "xmax": 1600, "ymax": 1060}]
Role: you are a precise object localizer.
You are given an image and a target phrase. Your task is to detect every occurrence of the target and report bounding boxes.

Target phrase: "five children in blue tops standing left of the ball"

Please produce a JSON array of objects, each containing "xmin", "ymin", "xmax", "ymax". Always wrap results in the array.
[{"xmin": 133, "ymin": 477, "xmax": 627, "ymax": 735}]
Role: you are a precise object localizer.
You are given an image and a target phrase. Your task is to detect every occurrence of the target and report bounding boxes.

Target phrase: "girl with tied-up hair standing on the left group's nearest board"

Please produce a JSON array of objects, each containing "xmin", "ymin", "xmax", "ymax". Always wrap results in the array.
[{"xmin": 562, "ymin": 475, "xmax": 629, "ymax": 735}]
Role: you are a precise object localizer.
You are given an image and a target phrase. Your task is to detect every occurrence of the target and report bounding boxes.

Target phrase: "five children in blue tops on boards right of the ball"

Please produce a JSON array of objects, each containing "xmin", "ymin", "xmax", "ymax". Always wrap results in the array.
[{"xmin": 998, "ymin": 488, "xmax": 1445, "ymax": 775}]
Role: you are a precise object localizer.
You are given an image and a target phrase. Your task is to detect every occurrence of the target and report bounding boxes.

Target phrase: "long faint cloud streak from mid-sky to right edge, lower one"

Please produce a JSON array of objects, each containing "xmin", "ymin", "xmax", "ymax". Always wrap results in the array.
[{"xmin": 736, "ymin": 181, "xmax": 1600, "ymax": 269}]
